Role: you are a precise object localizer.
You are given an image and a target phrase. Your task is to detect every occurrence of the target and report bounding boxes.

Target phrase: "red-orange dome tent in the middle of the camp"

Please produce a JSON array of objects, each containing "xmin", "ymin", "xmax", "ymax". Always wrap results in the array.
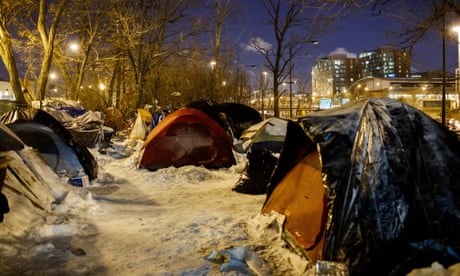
[{"xmin": 138, "ymin": 108, "xmax": 236, "ymax": 170}]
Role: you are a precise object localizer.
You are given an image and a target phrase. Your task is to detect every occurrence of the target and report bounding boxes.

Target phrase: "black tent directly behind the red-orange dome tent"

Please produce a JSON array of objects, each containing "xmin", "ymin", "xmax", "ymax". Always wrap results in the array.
[{"xmin": 186, "ymin": 100, "xmax": 262, "ymax": 139}]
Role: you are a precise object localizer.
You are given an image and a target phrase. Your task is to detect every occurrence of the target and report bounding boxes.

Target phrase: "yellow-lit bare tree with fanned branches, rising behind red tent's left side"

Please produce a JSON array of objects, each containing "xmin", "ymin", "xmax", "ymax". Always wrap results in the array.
[{"xmin": 113, "ymin": 0, "xmax": 198, "ymax": 111}]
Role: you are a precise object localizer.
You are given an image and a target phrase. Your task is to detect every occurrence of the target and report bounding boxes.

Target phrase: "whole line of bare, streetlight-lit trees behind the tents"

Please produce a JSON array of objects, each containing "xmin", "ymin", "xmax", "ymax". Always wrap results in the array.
[{"xmin": 0, "ymin": 0, "xmax": 459, "ymax": 116}]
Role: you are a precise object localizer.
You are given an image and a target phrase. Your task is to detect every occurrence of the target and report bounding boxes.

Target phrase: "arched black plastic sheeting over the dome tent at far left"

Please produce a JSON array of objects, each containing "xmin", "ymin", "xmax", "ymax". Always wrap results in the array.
[{"xmin": 0, "ymin": 108, "xmax": 98, "ymax": 181}]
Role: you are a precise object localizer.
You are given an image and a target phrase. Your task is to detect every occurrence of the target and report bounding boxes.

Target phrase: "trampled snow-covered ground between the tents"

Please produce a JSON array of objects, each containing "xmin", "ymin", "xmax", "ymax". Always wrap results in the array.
[{"xmin": 0, "ymin": 135, "xmax": 460, "ymax": 276}]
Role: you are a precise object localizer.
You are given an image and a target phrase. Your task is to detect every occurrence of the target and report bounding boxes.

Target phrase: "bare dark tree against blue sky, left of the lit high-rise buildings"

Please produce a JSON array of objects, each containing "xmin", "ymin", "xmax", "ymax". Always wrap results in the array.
[{"xmin": 251, "ymin": 0, "xmax": 399, "ymax": 117}]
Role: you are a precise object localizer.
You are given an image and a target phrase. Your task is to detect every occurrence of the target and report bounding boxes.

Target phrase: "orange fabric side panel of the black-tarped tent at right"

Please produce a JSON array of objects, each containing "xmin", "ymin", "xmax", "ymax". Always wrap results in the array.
[{"xmin": 262, "ymin": 151, "xmax": 327, "ymax": 263}]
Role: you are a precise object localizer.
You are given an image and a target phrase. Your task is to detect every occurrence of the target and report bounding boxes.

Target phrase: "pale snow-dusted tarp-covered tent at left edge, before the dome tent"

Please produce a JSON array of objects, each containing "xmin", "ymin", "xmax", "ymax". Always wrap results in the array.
[{"xmin": 0, "ymin": 147, "xmax": 71, "ymax": 234}]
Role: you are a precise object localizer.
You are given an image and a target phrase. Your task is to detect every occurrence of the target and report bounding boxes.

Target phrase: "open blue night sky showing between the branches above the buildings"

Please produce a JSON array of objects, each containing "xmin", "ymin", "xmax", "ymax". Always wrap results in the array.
[{"xmin": 234, "ymin": 1, "xmax": 458, "ymax": 81}]
